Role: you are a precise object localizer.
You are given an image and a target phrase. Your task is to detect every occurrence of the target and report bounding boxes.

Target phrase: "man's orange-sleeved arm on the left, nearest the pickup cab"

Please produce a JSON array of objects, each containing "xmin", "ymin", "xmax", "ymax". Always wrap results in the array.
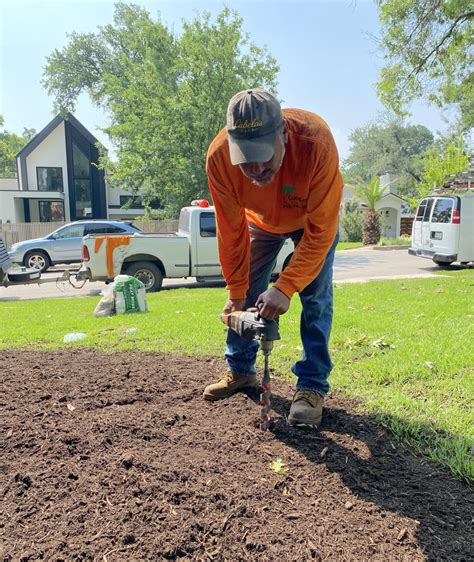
[{"xmin": 207, "ymin": 158, "xmax": 250, "ymax": 300}]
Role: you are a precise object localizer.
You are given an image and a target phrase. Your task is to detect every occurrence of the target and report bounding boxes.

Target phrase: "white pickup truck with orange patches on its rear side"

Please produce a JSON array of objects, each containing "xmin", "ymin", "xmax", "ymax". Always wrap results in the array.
[{"xmin": 77, "ymin": 206, "xmax": 294, "ymax": 291}]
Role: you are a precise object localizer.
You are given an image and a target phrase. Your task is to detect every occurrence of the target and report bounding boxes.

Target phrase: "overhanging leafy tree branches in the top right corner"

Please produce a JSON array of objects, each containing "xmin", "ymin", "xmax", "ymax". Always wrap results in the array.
[{"xmin": 377, "ymin": 0, "xmax": 474, "ymax": 130}]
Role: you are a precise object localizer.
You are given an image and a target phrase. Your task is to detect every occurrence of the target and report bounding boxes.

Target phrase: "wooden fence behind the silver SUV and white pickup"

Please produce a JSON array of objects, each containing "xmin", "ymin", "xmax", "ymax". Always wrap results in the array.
[{"xmin": 0, "ymin": 220, "xmax": 178, "ymax": 249}]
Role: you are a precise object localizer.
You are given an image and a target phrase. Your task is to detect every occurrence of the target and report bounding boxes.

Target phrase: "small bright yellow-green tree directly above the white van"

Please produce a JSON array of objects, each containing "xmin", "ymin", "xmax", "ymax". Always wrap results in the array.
[{"xmin": 408, "ymin": 135, "xmax": 469, "ymax": 209}]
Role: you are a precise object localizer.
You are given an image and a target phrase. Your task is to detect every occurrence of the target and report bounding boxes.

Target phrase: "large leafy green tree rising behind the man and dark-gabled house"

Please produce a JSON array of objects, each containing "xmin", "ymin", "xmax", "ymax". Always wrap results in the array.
[{"xmin": 43, "ymin": 3, "xmax": 279, "ymax": 215}]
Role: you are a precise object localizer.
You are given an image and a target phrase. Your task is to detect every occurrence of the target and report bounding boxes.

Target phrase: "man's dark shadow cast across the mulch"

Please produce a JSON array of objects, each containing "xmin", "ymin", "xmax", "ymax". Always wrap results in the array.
[{"xmin": 264, "ymin": 390, "xmax": 474, "ymax": 560}]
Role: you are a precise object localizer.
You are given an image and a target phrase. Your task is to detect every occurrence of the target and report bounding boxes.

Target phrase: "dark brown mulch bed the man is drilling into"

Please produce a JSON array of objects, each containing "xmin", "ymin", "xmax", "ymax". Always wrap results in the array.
[{"xmin": 0, "ymin": 349, "xmax": 473, "ymax": 562}]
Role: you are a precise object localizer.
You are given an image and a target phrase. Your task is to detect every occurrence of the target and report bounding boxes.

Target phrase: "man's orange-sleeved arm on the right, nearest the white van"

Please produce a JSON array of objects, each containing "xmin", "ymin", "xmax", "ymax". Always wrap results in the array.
[{"xmin": 274, "ymin": 137, "xmax": 343, "ymax": 298}]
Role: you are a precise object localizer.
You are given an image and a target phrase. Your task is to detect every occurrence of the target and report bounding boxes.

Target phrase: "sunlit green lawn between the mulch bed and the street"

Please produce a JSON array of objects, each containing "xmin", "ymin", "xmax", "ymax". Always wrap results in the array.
[{"xmin": 0, "ymin": 270, "xmax": 474, "ymax": 481}]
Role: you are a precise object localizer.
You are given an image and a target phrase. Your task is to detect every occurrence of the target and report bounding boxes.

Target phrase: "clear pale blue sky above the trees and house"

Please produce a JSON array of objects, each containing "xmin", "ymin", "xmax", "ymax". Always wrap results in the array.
[{"xmin": 0, "ymin": 0, "xmax": 452, "ymax": 157}]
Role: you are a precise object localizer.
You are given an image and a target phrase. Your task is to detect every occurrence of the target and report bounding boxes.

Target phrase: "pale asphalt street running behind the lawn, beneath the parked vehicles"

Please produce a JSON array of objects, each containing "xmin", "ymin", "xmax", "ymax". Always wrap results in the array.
[{"xmin": 0, "ymin": 247, "xmax": 452, "ymax": 301}]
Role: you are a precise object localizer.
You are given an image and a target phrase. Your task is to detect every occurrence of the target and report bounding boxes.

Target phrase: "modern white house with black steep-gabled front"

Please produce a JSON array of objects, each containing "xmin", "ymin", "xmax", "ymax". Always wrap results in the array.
[{"xmin": 0, "ymin": 114, "xmax": 144, "ymax": 223}]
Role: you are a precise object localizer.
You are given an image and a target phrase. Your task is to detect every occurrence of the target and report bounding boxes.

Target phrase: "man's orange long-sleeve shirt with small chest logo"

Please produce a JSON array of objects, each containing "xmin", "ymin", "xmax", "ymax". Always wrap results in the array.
[{"xmin": 206, "ymin": 109, "xmax": 343, "ymax": 299}]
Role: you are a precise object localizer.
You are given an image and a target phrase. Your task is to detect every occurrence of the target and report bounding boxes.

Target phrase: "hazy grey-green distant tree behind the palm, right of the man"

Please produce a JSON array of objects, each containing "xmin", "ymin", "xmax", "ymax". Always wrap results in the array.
[{"xmin": 343, "ymin": 119, "xmax": 433, "ymax": 196}]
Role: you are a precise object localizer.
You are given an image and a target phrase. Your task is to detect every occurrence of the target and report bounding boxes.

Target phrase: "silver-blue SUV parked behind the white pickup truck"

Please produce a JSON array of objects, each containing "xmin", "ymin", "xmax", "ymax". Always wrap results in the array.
[{"xmin": 8, "ymin": 220, "xmax": 141, "ymax": 272}]
